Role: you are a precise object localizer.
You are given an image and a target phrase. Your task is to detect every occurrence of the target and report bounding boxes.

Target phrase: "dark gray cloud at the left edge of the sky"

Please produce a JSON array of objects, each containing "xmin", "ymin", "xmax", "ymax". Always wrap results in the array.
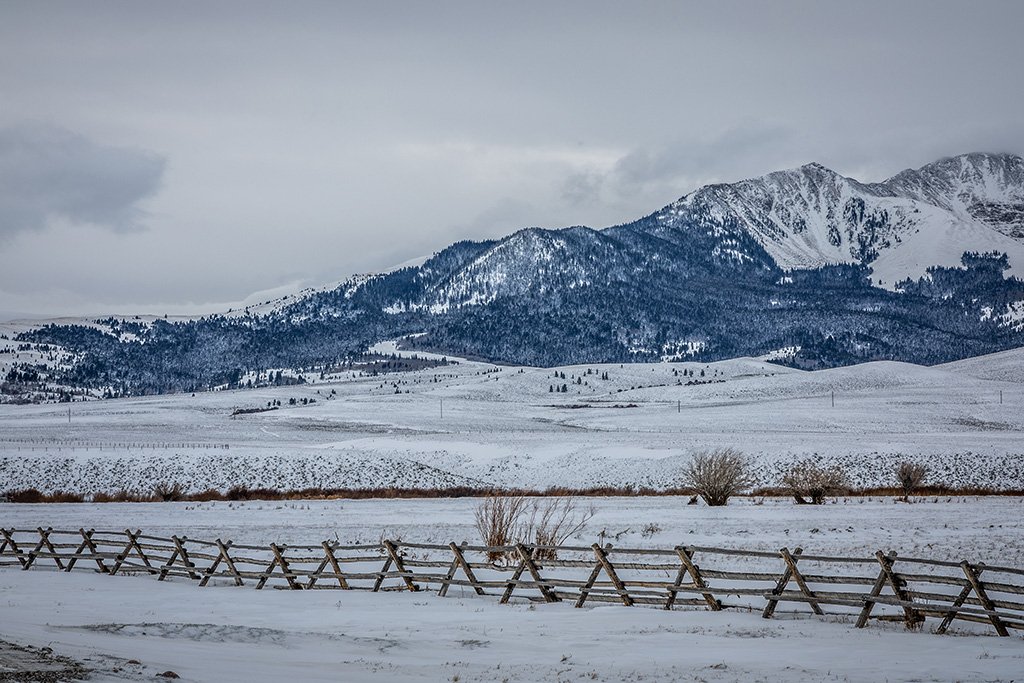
[{"xmin": 0, "ymin": 124, "xmax": 166, "ymax": 238}]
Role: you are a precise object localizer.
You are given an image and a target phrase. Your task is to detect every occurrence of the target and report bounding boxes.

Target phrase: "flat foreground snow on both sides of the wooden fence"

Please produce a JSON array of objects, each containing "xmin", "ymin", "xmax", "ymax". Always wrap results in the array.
[{"xmin": 0, "ymin": 497, "xmax": 1024, "ymax": 681}]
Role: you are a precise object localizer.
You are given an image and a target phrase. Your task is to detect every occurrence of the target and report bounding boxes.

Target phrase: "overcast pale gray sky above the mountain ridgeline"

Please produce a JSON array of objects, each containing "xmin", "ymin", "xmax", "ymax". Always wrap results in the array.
[{"xmin": 0, "ymin": 0, "xmax": 1024, "ymax": 319}]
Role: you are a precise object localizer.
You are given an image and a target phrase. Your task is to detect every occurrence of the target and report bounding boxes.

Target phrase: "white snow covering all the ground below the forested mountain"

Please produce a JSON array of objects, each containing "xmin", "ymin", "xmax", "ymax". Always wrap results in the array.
[{"xmin": 0, "ymin": 342, "xmax": 1024, "ymax": 683}]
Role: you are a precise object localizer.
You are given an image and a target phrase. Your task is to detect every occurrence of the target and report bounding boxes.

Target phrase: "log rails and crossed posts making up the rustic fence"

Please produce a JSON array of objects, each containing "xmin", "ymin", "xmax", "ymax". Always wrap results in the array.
[{"xmin": 0, "ymin": 527, "xmax": 1024, "ymax": 636}]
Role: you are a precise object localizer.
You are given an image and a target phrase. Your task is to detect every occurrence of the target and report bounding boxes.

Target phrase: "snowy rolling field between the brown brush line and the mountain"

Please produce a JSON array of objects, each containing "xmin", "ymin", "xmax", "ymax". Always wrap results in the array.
[{"xmin": 0, "ymin": 345, "xmax": 1024, "ymax": 493}]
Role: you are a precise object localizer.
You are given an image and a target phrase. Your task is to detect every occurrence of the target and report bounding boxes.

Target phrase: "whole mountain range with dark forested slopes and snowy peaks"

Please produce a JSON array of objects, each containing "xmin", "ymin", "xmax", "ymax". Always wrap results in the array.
[{"xmin": 8, "ymin": 154, "xmax": 1024, "ymax": 394}]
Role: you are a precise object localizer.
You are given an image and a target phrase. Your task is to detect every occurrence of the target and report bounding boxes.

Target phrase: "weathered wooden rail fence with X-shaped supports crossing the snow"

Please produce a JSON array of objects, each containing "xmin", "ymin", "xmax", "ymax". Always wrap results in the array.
[{"xmin": 0, "ymin": 527, "xmax": 1024, "ymax": 636}]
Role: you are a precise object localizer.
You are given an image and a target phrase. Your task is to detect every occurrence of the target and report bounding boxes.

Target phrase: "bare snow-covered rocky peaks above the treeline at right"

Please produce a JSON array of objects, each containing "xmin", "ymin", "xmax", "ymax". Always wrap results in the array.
[{"xmin": 654, "ymin": 154, "xmax": 1024, "ymax": 287}]
